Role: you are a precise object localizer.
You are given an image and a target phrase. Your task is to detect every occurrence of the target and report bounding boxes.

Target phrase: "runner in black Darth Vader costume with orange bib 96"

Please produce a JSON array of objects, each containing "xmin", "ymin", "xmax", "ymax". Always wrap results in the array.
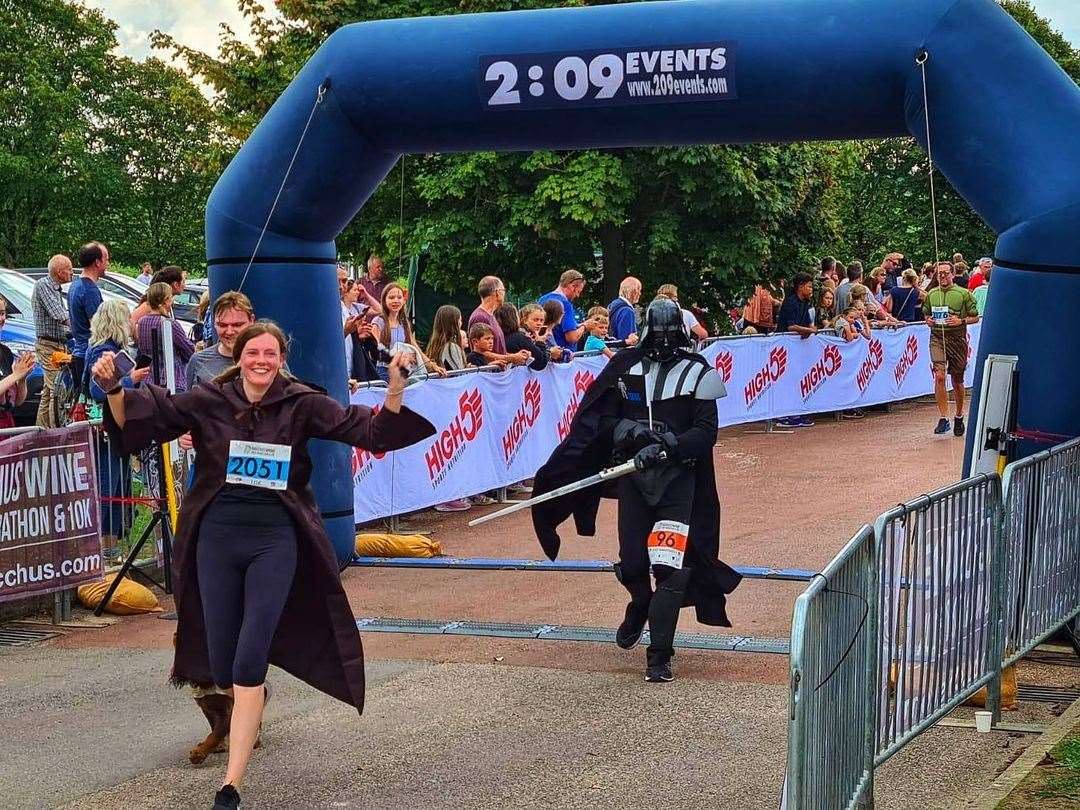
[{"xmin": 532, "ymin": 299, "xmax": 741, "ymax": 681}]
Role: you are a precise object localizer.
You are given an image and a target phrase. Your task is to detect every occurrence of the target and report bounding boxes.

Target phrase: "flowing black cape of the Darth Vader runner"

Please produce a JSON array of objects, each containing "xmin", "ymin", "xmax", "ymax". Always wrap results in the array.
[{"xmin": 531, "ymin": 348, "xmax": 742, "ymax": 627}]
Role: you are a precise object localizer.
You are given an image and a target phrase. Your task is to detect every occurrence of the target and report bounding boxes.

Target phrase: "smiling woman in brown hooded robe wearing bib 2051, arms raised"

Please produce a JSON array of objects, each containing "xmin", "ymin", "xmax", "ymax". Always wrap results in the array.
[{"xmin": 93, "ymin": 321, "xmax": 435, "ymax": 808}]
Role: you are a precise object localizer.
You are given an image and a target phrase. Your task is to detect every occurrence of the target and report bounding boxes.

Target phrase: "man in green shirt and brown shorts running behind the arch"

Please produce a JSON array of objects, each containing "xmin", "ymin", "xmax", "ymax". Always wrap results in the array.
[{"xmin": 922, "ymin": 261, "xmax": 978, "ymax": 436}]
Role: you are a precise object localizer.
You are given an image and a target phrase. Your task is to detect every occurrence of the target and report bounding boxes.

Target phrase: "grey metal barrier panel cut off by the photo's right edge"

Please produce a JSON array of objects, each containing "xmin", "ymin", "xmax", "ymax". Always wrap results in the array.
[{"xmin": 1002, "ymin": 438, "xmax": 1080, "ymax": 664}]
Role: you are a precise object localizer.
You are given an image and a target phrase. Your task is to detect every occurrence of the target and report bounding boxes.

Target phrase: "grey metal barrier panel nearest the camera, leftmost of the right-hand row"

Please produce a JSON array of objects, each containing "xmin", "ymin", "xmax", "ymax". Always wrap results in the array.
[{"xmin": 787, "ymin": 526, "xmax": 877, "ymax": 810}]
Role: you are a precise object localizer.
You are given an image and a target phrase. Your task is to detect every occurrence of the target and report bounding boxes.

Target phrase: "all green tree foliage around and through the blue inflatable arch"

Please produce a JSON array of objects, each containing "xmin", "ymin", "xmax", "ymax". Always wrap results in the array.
[{"xmin": 0, "ymin": 0, "xmax": 1080, "ymax": 306}]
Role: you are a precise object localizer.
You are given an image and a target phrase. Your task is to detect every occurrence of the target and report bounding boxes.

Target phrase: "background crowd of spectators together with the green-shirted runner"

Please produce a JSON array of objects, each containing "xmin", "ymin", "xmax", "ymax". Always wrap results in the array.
[{"xmin": 0, "ymin": 242, "xmax": 993, "ymax": 534}]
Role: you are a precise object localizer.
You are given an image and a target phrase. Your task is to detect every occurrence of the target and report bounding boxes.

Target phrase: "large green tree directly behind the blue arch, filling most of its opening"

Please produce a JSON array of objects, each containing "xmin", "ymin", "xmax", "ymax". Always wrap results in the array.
[{"xmin": 156, "ymin": 0, "xmax": 840, "ymax": 324}]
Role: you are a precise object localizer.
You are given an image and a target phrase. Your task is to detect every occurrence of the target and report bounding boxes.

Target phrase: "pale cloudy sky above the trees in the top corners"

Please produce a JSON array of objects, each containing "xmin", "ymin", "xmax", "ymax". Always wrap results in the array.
[{"xmin": 83, "ymin": 0, "xmax": 1080, "ymax": 58}]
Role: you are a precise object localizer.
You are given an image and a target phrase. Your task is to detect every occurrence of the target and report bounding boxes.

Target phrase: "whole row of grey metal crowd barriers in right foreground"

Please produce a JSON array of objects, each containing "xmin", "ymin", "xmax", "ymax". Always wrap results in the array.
[{"xmin": 785, "ymin": 438, "xmax": 1080, "ymax": 808}]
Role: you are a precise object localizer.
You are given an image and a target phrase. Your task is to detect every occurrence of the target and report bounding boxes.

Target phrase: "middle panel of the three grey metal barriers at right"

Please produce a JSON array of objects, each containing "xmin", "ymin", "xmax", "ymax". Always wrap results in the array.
[{"xmin": 875, "ymin": 475, "xmax": 1002, "ymax": 764}]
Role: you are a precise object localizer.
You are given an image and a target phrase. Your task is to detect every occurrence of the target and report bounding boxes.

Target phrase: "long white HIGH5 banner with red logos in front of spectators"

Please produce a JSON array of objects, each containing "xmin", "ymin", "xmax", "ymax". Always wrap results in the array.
[{"xmin": 352, "ymin": 325, "xmax": 978, "ymax": 523}]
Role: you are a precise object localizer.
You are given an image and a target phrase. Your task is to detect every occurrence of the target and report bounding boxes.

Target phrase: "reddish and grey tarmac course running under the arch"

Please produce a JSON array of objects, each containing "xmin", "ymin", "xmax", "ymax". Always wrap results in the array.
[{"xmin": 0, "ymin": 404, "xmax": 1024, "ymax": 809}]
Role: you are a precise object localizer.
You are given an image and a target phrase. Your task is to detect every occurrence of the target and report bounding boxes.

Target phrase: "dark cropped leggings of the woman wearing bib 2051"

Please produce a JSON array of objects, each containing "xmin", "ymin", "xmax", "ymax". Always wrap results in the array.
[{"xmin": 195, "ymin": 519, "xmax": 296, "ymax": 689}]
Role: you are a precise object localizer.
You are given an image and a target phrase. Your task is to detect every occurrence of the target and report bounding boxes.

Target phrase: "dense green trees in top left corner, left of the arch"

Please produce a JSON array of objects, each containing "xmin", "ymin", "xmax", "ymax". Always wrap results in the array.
[{"xmin": 0, "ymin": 0, "xmax": 223, "ymax": 273}]
